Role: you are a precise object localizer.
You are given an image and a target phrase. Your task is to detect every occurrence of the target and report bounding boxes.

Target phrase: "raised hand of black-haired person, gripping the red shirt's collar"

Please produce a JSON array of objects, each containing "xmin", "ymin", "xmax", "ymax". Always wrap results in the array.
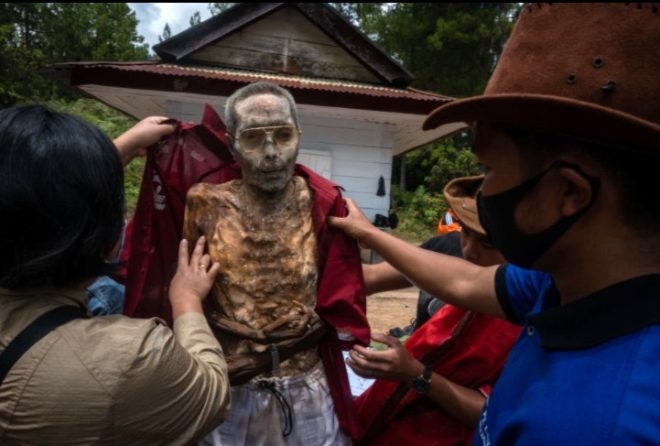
[{"xmin": 114, "ymin": 116, "xmax": 176, "ymax": 166}]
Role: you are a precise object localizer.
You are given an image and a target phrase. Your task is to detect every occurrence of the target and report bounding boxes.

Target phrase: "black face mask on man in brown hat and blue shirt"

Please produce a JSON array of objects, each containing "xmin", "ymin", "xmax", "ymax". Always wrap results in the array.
[{"xmin": 477, "ymin": 161, "xmax": 600, "ymax": 268}]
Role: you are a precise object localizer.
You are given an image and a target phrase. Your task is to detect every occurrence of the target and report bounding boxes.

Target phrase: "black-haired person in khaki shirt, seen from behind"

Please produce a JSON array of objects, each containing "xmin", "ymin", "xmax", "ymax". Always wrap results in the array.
[{"xmin": 0, "ymin": 105, "xmax": 230, "ymax": 445}]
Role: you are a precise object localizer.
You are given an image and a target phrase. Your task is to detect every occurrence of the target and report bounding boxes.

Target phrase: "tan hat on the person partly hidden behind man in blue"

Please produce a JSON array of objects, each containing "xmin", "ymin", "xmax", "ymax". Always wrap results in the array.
[{"xmin": 442, "ymin": 175, "xmax": 486, "ymax": 236}]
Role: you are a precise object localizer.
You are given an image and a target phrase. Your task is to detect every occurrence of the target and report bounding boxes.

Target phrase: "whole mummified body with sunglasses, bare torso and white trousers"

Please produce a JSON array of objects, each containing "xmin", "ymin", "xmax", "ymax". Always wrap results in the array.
[{"xmin": 184, "ymin": 82, "xmax": 360, "ymax": 446}]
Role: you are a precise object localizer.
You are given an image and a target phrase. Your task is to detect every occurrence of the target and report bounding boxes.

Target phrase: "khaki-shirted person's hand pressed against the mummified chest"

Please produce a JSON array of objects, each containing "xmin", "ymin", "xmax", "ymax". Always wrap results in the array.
[{"xmin": 169, "ymin": 236, "xmax": 220, "ymax": 319}]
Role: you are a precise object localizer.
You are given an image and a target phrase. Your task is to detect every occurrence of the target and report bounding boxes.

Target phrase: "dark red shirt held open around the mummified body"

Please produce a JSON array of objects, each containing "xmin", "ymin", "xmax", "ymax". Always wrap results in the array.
[{"xmin": 118, "ymin": 106, "xmax": 370, "ymax": 437}]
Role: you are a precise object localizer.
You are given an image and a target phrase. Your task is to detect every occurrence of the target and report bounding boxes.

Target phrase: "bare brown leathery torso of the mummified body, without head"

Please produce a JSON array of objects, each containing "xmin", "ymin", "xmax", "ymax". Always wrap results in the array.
[{"xmin": 184, "ymin": 177, "xmax": 319, "ymax": 376}]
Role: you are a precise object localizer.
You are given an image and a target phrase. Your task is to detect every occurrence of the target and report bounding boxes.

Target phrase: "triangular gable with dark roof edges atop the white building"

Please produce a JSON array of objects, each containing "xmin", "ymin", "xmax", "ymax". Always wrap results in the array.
[{"xmin": 153, "ymin": 3, "xmax": 414, "ymax": 88}]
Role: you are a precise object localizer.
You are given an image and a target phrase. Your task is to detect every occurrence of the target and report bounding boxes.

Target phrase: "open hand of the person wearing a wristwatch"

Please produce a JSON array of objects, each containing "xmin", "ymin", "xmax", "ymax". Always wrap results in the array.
[{"xmin": 346, "ymin": 334, "xmax": 424, "ymax": 381}]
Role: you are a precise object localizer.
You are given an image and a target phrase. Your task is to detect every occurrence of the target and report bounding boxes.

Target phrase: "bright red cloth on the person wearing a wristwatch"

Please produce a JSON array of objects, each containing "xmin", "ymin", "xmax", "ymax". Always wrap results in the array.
[{"xmin": 356, "ymin": 304, "xmax": 520, "ymax": 446}]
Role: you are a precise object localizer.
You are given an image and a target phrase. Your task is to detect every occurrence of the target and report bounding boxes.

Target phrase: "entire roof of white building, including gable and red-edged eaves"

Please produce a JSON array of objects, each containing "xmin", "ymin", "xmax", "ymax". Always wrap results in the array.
[{"xmin": 49, "ymin": 3, "xmax": 465, "ymax": 159}]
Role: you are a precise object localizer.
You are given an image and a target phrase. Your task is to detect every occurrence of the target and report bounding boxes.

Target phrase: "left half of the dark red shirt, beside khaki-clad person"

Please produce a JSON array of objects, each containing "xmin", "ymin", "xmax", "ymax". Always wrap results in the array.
[{"xmin": 117, "ymin": 106, "xmax": 240, "ymax": 320}]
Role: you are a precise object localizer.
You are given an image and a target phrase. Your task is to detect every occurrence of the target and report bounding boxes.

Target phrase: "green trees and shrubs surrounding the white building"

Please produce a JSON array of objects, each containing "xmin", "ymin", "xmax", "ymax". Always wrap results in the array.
[{"xmin": 0, "ymin": 3, "xmax": 520, "ymax": 228}]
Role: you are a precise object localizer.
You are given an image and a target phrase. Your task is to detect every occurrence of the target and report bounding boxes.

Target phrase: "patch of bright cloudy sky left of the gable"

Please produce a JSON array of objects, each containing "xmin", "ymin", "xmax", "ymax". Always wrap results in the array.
[{"xmin": 128, "ymin": 3, "xmax": 217, "ymax": 53}]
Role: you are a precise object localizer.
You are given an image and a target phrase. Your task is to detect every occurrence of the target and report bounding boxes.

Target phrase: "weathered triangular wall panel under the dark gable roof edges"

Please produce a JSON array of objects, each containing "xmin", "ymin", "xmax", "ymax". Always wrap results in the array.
[{"xmin": 186, "ymin": 7, "xmax": 381, "ymax": 83}]
